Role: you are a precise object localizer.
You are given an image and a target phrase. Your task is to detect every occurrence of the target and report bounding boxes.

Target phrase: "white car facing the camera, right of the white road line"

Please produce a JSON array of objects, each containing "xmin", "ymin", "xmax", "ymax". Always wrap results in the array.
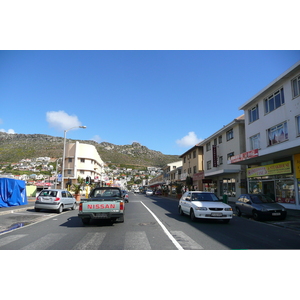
[{"xmin": 178, "ymin": 191, "xmax": 233, "ymax": 223}]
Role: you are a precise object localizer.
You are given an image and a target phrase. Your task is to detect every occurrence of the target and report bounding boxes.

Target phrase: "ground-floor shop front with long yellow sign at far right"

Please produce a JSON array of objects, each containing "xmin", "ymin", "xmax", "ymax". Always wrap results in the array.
[{"xmin": 247, "ymin": 158, "xmax": 300, "ymax": 209}]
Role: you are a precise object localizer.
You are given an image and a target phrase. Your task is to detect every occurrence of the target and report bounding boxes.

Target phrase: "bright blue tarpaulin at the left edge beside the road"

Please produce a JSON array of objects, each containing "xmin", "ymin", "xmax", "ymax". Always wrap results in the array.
[{"xmin": 0, "ymin": 178, "xmax": 28, "ymax": 207}]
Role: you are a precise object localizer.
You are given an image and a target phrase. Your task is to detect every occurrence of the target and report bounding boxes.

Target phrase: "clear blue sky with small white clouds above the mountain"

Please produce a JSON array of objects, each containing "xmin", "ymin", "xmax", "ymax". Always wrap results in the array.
[{"xmin": 0, "ymin": 50, "xmax": 300, "ymax": 155}]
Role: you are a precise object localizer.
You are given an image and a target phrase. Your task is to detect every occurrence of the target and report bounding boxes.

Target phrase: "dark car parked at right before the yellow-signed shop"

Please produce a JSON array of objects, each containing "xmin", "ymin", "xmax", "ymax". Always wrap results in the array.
[{"xmin": 235, "ymin": 194, "xmax": 287, "ymax": 220}]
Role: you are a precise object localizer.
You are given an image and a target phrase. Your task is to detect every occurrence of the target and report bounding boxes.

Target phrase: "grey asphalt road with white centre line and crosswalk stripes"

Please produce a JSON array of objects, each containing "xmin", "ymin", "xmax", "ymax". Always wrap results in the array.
[{"xmin": 0, "ymin": 193, "xmax": 300, "ymax": 250}]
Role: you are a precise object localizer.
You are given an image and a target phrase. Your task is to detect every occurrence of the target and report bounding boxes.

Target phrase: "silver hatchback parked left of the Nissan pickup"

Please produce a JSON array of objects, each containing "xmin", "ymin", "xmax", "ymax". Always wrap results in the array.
[{"xmin": 34, "ymin": 189, "xmax": 76, "ymax": 213}]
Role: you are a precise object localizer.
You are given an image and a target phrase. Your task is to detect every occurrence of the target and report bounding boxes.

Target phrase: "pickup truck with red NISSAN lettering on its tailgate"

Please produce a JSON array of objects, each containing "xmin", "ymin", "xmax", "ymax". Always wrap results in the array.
[{"xmin": 78, "ymin": 187, "xmax": 125, "ymax": 225}]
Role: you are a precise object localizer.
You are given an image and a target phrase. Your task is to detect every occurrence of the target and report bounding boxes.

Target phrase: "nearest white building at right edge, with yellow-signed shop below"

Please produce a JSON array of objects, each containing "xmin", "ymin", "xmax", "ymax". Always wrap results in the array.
[{"xmin": 231, "ymin": 61, "xmax": 300, "ymax": 209}]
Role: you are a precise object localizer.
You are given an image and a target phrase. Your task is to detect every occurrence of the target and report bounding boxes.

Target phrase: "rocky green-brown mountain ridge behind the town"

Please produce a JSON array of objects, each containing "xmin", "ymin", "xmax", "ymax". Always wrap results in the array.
[{"xmin": 0, "ymin": 132, "xmax": 180, "ymax": 167}]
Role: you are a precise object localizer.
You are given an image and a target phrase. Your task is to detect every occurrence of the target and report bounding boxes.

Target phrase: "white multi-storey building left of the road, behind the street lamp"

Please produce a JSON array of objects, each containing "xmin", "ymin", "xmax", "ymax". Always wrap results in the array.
[{"xmin": 64, "ymin": 142, "xmax": 104, "ymax": 186}]
